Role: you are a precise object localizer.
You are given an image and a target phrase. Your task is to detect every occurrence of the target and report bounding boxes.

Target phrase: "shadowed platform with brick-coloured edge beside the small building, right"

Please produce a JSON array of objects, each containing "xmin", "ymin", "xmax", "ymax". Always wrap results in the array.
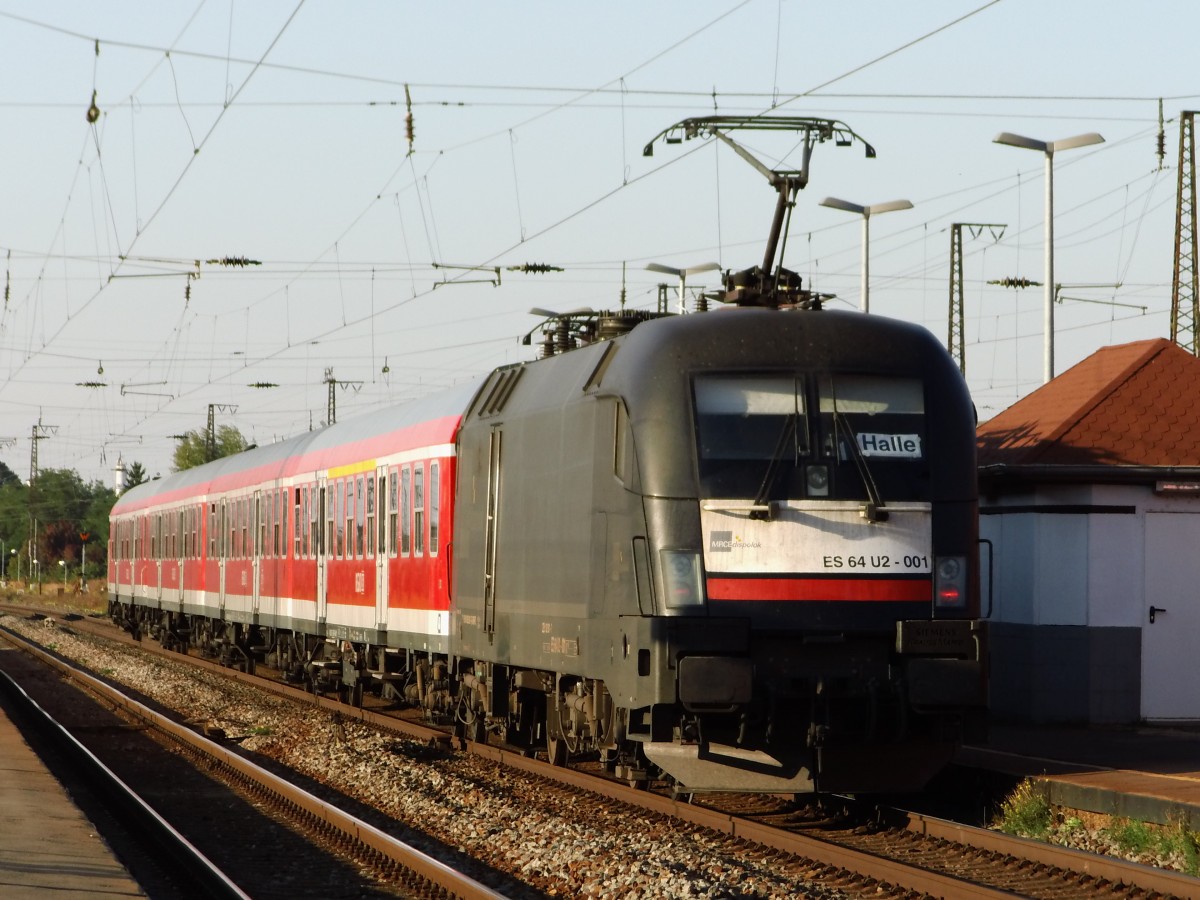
[{"xmin": 954, "ymin": 725, "xmax": 1200, "ymax": 830}]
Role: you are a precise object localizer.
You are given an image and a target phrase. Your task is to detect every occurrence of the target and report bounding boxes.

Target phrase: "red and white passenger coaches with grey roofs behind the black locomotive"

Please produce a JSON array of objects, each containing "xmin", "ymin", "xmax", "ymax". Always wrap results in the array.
[{"xmin": 108, "ymin": 384, "xmax": 478, "ymax": 664}]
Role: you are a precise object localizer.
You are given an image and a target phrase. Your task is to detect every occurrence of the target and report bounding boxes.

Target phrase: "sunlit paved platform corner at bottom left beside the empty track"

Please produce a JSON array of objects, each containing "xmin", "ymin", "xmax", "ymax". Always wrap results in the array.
[{"xmin": 0, "ymin": 707, "xmax": 145, "ymax": 898}]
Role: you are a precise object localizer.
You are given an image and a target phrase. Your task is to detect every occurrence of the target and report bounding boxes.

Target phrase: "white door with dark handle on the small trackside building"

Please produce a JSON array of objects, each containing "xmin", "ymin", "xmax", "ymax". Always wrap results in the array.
[{"xmin": 1141, "ymin": 512, "xmax": 1200, "ymax": 720}]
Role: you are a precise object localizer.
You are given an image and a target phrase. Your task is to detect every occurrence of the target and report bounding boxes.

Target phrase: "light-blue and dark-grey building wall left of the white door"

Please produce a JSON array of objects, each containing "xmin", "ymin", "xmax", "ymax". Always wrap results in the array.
[{"xmin": 979, "ymin": 485, "xmax": 1161, "ymax": 724}]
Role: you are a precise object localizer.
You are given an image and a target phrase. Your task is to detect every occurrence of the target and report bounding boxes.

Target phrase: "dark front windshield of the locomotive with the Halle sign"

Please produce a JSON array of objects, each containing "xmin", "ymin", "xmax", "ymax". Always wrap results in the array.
[{"xmin": 695, "ymin": 373, "xmax": 929, "ymax": 503}]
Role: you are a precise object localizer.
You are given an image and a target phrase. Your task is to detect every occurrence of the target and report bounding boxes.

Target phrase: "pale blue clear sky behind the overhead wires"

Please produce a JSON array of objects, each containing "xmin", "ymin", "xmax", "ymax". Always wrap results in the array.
[{"xmin": 0, "ymin": 0, "xmax": 1200, "ymax": 484}]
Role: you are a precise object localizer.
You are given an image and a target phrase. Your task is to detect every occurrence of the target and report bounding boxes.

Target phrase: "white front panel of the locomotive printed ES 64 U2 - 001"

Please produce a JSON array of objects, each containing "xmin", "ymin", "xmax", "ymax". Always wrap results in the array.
[{"xmin": 700, "ymin": 500, "xmax": 934, "ymax": 575}]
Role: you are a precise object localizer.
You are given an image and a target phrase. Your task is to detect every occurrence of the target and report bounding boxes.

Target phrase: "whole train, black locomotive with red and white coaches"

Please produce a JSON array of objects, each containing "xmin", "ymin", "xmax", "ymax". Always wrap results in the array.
[{"xmin": 108, "ymin": 298, "xmax": 986, "ymax": 793}]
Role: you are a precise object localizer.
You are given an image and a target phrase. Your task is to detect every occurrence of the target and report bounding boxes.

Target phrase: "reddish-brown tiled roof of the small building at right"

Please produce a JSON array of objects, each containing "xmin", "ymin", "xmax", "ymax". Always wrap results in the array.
[{"xmin": 976, "ymin": 338, "xmax": 1200, "ymax": 466}]
